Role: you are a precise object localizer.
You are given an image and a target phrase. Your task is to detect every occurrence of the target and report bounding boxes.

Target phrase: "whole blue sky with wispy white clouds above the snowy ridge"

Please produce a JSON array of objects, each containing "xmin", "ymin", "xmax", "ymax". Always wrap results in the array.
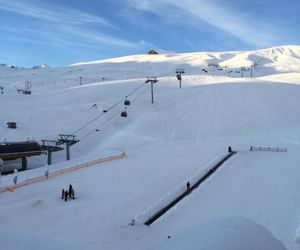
[{"xmin": 0, "ymin": 0, "xmax": 300, "ymax": 67}]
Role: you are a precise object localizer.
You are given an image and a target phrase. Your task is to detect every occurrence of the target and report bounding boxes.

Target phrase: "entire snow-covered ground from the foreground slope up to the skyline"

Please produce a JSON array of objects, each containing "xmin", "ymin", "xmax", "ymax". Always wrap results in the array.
[{"xmin": 0, "ymin": 46, "xmax": 300, "ymax": 250}]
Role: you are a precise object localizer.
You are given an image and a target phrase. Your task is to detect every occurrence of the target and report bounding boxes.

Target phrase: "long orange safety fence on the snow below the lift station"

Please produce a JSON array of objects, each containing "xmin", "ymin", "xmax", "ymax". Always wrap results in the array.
[{"xmin": 0, "ymin": 152, "xmax": 126, "ymax": 193}]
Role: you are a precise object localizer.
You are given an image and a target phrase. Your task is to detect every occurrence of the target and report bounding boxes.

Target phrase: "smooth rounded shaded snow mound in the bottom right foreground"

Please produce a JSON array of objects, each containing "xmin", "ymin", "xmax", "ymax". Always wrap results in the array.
[{"xmin": 149, "ymin": 217, "xmax": 286, "ymax": 250}]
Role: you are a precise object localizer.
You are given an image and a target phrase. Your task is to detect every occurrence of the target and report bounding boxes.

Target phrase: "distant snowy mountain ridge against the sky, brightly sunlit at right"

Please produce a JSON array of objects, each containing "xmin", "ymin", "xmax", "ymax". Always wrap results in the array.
[{"xmin": 0, "ymin": 46, "xmax": 300, "ymax": 86}]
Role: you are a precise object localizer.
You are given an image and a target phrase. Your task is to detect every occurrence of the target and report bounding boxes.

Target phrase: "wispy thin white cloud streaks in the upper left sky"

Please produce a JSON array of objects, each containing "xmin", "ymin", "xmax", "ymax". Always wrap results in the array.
[{"xmin": 0, "ymin": 0, "xmax": 148, "ymax": 49}]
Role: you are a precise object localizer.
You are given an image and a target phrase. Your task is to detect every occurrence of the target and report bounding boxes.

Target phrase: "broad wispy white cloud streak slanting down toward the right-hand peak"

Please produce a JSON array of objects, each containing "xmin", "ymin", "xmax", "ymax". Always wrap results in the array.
[{"xmin": 127, "ymin": 0, "xmax": 275, "ymax": 47}]
